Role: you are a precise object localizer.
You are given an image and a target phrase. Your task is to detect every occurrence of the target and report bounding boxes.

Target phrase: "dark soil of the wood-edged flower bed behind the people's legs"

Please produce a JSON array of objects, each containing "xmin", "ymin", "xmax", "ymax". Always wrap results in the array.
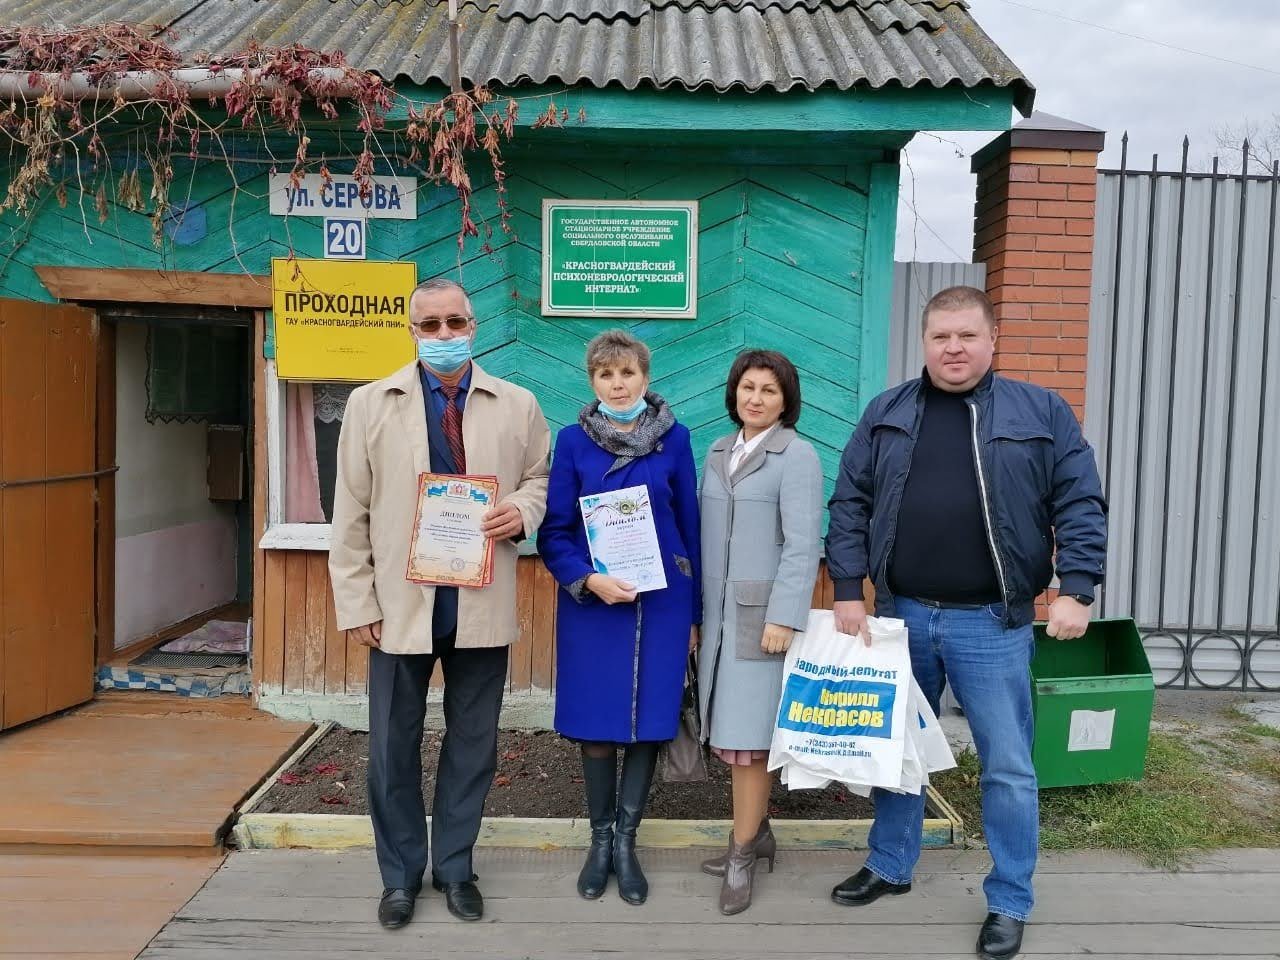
[{"xmin": 255, "ymin": 727, "xmax": 872, "ymax": 820}]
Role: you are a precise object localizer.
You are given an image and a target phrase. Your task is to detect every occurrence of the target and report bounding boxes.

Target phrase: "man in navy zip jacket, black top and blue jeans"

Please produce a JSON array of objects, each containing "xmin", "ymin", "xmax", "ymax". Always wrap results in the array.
[{"xmin": 827, "ymin": 287, "xmax": 1106, "ymax": 957}]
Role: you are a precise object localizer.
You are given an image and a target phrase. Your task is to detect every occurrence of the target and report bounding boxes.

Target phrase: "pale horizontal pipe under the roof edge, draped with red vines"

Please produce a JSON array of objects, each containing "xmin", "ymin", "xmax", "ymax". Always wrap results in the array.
[{"xmin": 0, "ymin": 67, "xmax": 356, "ymax": 101}]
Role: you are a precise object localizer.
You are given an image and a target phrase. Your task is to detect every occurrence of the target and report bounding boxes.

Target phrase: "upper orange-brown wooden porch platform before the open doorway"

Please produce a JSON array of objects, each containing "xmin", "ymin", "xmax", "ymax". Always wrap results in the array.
[{"xmin": 0, "ymin": 691, "xmax": 310, "ymax": 850}]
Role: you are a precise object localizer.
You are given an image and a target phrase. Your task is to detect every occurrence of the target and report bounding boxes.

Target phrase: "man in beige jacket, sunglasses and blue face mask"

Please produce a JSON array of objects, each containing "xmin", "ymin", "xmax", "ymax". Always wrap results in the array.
[{"xmin": 329, "ymin": 279, "xmax": 550, "ymax": 928}]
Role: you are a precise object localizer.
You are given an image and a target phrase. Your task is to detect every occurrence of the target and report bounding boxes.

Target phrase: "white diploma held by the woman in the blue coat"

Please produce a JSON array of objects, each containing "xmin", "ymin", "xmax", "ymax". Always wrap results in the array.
[{"xmin": 579, "ymin": 485, "xmax": 667, "ymax": 593}]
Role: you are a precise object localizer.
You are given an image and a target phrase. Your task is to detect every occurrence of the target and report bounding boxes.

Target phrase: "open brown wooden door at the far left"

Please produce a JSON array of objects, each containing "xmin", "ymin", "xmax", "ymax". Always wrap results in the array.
[{"xmin": 0, "ymin": 300, "xmax": 99, "ymax": 728}]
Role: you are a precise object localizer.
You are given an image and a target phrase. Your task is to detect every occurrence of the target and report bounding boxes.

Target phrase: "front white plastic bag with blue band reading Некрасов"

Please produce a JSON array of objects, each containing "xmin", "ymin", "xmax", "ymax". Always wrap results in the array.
[{"xmin": 769, "ymin": 611, "xmax": 915, "ymax": 788}]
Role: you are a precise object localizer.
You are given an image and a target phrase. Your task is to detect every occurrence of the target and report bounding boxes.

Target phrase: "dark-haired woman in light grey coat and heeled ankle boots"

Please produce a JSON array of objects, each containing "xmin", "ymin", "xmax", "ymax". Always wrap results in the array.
[{"xmin": 698, "ymin": 349, "xmax": 822, "ymax": 914}]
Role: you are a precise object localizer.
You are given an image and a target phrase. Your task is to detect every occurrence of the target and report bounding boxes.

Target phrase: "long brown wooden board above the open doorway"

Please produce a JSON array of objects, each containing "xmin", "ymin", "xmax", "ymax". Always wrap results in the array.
[{"xmin": 36, "ymin": 266, "xmax": 271, "ymax": 310}]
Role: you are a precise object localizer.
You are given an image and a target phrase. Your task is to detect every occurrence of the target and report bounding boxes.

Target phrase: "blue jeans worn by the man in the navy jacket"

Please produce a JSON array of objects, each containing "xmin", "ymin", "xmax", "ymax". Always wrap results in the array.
[{"xmin": 867, "ymin": 596, "xmax": 1039, "ymax": 920}]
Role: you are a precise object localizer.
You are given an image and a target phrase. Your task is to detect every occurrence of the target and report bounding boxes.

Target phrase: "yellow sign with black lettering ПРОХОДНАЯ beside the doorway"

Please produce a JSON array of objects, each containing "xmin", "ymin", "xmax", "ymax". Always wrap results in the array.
[{"xmin": 271, "ymin": 257, "xmax": 417, "ymax": 381}]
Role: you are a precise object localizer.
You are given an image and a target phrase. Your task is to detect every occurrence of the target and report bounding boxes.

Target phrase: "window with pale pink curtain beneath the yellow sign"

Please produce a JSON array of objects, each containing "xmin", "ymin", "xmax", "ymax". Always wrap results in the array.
[{"xmin": 284, "ymin": 380, "xmax": 357, "ymax": 524}]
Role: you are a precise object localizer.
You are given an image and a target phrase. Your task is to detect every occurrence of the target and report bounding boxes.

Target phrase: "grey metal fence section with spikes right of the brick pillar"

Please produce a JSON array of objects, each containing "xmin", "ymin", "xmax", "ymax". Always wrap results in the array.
[{"xmin": 1085, "ymin": 138, "xmax": 1280, "ymax": 690}]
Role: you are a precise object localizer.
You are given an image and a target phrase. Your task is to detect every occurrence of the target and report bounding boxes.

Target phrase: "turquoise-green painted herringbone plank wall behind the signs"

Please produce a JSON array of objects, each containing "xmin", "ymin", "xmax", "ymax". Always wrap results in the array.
[{"xmin": 0, "ymin": 151, "xmax": 897, "ymax": 499}]
